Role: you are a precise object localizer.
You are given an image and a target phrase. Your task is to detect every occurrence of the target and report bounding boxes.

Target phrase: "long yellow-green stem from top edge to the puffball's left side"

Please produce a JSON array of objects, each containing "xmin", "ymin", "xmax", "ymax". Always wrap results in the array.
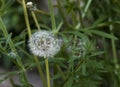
[{"xmin": 22, "ymin": 0, "xmax": 31, "ymax": 37}]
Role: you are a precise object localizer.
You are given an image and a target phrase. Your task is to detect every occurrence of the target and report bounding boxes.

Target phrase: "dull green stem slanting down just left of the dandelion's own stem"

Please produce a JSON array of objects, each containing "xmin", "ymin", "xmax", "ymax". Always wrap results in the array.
[{"xmin": 34, "ymin": 56, "xmax": 47, "ymax": 87}]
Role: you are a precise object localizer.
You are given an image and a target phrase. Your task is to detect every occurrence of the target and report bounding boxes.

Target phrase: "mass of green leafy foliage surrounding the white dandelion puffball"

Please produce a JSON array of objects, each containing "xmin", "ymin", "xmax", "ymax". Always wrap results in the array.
[{"xmin": 0, "ymin": 0, "xmax": 120, "ymax": 87}]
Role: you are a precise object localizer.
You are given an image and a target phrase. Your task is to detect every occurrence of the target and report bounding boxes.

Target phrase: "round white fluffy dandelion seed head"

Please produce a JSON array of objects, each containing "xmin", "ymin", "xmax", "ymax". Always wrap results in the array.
[{"xmin": 29, "ymin": 30, "xmax": 61, "ymax": 58}]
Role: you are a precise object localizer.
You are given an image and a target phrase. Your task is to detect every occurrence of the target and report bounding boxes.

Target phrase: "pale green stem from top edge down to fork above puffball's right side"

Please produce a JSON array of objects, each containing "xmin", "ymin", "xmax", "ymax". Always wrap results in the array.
[{"xmin": 48, "ymin": 0, "xmax": 56, "ymax": 30}]
